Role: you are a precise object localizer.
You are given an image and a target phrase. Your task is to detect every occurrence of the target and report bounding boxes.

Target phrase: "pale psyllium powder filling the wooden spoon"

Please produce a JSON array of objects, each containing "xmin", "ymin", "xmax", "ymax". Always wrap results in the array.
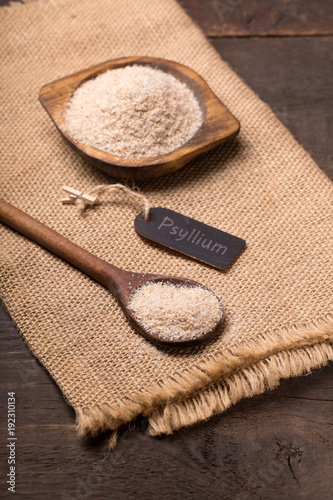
[{"xmin": 129, "ymin": 282, "xmax": 223, "ymax": 340}]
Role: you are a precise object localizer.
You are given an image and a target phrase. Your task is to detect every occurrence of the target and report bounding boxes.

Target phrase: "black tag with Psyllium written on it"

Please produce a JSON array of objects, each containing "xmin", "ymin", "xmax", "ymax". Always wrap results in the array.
[{"xmin": 134, "ymin": 207, "xmax": 245, "ymax": 269}]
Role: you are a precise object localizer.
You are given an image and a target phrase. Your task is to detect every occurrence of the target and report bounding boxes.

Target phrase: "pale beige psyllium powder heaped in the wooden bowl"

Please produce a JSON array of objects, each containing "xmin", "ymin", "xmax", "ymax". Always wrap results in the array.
[{"xmin": 64, "ymin": 65, "xmax": 203, "ymax": 158}]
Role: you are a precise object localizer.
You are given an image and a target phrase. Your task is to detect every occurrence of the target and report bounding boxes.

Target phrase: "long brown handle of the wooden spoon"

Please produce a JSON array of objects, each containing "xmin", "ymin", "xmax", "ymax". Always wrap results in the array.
[{"xmin": 0, "ymin": 199, "xmax": 127, "ymax": 293}]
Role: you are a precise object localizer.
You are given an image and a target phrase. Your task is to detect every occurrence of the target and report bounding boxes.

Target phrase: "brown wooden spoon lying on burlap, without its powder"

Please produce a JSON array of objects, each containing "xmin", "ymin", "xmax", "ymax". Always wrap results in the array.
[{"xmin": 0, "ymin": 200, "xmax": 223, "ymax": 348}]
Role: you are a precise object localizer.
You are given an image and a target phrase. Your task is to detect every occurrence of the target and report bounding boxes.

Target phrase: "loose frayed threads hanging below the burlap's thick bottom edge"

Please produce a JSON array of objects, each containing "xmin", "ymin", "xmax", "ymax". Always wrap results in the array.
[{"xmin": 148, "ymin": 343, "xmax": 333, "ymax": 436}]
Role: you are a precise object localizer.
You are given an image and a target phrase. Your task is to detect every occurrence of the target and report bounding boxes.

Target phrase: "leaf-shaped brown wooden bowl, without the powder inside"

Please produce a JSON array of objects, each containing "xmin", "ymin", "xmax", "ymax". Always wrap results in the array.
[{"xmin": 39, "ymin": 57, "xmax": 240, "ymax": 179}]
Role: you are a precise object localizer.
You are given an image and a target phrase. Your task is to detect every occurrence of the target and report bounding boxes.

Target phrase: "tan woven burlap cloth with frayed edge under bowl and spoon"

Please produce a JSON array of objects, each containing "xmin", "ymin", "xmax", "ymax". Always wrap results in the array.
[{"xmin": 0, "ymin": 0, "xmax": 333, "ymax": 442}]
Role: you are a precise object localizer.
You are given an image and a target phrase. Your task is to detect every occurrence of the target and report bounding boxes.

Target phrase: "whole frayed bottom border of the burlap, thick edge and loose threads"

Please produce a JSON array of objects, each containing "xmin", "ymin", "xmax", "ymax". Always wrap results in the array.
[{"xmin": 76, "ymin": 315, "xmax": 333, "ymax": 448}]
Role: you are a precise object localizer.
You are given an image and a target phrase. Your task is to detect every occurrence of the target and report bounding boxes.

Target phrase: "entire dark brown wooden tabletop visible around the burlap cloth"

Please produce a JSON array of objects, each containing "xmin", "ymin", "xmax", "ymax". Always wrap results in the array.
[{"xmin": 0, "ymin": 0, "xmax": 333, "ymax": 500}]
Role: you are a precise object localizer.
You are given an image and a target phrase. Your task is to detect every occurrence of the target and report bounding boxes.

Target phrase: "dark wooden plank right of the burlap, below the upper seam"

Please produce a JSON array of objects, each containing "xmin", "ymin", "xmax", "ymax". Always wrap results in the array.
[{"xmin": 212, "ymin": 37, "xmax": 333, "ymax": 180}]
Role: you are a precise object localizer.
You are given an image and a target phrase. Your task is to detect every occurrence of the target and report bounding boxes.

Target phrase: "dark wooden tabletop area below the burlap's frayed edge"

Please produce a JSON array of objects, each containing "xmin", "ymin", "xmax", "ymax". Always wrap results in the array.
[{"xmin": 0, "ymin": 302, "xmax": 333, "ymax": 500}]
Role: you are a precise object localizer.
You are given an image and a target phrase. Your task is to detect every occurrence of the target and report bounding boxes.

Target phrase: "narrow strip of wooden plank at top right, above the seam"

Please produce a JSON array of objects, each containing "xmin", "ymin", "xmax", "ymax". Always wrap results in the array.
[{"xmin": 178, "ymin": 0, "xmax": 333, "ymax": 37}]
